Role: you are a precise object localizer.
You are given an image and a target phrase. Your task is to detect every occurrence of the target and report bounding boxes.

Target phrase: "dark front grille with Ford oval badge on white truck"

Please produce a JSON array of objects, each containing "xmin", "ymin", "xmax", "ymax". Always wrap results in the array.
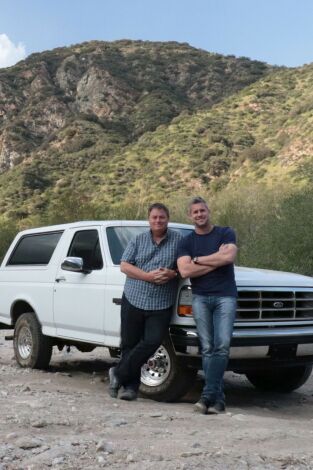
[{"xmin": 236, "ymin": 290, "xmax": 313, "ymax": 321}]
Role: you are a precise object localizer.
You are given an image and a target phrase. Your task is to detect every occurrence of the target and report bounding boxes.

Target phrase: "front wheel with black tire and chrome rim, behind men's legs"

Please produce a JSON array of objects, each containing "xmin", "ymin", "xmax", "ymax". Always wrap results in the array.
[{"xmin": 140, "ymin": 338, "xmax": 198, "ymax": 402}]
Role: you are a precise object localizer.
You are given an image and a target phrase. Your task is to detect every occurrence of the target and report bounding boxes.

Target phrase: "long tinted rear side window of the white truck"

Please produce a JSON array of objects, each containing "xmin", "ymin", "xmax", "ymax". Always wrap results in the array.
[{"xmin": 7, "ymin": 232, "xmax": 63, "ymax": 266}]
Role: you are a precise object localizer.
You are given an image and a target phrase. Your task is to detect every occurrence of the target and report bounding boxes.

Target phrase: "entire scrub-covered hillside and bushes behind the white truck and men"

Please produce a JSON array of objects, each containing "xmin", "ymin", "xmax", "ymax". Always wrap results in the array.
[{"xmin": 0, "ymin": 41, "xmax": 313, "ymax": 275}]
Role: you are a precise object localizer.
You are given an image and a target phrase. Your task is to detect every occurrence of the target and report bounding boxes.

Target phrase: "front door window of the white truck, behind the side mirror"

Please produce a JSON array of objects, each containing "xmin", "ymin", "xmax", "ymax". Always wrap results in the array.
[{"xmin": 67, "ymin": 230, "xmax": 103, "ymax": 270}]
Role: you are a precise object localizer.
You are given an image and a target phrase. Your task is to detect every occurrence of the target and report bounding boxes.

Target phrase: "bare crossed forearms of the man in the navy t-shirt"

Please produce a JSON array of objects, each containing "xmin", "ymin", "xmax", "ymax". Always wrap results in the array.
[{"xmin": 177, "ymin": 243, "xmax": 237, "ymax": 278}]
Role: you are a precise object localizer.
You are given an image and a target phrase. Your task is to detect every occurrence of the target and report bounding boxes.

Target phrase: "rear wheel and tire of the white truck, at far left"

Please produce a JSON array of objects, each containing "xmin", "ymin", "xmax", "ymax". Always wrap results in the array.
[{"xmin": 13, "ymin": 313, "xmax": 53, "ymax": 369}]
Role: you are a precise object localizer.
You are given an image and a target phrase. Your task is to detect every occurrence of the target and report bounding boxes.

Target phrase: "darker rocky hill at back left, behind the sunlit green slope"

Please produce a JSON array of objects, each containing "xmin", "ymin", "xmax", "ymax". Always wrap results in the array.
[{"xmin": 0, "ymin": 41, "xmax": 271, "ymax": 172}]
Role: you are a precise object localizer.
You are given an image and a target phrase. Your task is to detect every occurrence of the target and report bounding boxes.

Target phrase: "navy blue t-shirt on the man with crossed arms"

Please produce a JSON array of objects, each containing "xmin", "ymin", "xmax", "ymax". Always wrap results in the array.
[{"xmin": 178, "ymin": 226, "xmax": 237, "ymax": 297}]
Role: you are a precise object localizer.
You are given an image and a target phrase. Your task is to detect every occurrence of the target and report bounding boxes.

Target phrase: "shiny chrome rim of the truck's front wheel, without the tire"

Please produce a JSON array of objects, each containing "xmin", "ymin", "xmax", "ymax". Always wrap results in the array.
[{"xmin": 141, "ymin": 346, "xmax": 171, "ymax": 387}]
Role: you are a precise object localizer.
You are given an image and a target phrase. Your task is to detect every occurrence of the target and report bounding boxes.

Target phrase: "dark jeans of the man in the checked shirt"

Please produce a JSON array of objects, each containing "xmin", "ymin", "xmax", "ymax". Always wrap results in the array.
[{"xmin": 115, "ymin": 295, "xmax": 172, "ymax": 391}]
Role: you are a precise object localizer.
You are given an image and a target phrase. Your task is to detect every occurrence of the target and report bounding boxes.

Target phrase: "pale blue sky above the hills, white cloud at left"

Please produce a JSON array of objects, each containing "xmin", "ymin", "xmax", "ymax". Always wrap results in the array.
[{"xmin": 0, "ymin": 0, "xmax": 313, "ymax": 67}]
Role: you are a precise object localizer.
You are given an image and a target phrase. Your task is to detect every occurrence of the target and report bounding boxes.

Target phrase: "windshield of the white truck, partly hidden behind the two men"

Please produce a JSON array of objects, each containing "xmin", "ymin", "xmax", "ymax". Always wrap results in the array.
[{"xmin": 106, "ymin": 226, "xmax": 192, "ymax": 264}]
